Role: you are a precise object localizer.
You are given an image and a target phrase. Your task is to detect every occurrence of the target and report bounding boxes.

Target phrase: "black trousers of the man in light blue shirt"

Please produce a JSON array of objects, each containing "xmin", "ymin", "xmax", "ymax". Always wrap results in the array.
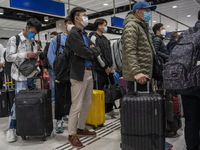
[{"xmin": 55, "ymin": 81, "xmax": 71, "ymax": 120}]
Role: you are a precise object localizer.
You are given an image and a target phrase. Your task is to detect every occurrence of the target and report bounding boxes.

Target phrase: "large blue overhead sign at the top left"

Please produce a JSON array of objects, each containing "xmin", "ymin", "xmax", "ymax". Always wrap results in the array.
[{"xmin": 10, "ymin": 0, "xmax": 65, "ymax": 16}]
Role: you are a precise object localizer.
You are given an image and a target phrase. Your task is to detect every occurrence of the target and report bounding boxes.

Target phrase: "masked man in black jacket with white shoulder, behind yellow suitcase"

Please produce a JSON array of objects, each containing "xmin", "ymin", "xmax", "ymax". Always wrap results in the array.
[{"xmin": 90, "ymin": 19, "xmax": 114, "ymax": 118}]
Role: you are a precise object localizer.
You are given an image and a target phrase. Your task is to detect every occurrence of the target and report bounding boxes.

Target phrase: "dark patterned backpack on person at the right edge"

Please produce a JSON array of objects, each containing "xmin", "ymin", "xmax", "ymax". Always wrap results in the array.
[{"xmin": 163, "ymin": 28, "xmax": 200, "ymax": 94}]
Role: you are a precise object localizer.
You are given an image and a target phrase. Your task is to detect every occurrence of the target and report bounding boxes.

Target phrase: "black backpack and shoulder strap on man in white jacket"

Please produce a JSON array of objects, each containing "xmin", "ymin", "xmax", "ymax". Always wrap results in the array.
[{"xmin": 4, "ymin": 35, "xmax": 20, "ymax": 76}]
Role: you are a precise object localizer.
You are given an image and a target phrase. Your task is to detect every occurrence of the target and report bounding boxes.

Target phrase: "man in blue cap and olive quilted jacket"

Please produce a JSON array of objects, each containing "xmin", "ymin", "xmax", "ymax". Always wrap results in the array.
[{"xmin": 122, "ymin": 1, "xmax": 156, "ymax": 91}]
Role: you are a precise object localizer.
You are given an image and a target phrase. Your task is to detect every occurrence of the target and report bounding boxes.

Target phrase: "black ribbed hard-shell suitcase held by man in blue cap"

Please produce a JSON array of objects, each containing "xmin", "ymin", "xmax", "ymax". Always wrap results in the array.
[{"xmin": 121, "ymin": 83, "xmax": 165, "ymax": 150}]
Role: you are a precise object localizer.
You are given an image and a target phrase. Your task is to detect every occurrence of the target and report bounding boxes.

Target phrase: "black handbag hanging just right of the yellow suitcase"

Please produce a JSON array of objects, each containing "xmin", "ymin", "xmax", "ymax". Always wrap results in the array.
[{"xmin": 103, "ymin": 77, "xmax": 126, "ymax": 103}]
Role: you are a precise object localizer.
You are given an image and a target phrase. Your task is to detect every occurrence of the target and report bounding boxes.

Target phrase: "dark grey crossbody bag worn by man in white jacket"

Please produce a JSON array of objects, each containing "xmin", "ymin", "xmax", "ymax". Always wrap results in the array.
[{"xmin": 18, "ymin": 58, "xmax": 39, "ymax": 77}]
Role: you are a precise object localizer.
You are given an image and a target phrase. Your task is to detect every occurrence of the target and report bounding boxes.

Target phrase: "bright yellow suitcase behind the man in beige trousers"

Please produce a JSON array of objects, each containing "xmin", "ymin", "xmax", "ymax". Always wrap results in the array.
[{"xmin": 86, "ymin": 90, "xmax": 105, "ymax": 128}]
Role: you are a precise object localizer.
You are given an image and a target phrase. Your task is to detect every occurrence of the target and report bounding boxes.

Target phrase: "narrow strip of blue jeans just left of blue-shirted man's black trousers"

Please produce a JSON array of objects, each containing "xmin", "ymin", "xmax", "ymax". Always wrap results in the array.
[{"xmin": 48, "ymin": 69, "xmax": 55, "ymax": 102}]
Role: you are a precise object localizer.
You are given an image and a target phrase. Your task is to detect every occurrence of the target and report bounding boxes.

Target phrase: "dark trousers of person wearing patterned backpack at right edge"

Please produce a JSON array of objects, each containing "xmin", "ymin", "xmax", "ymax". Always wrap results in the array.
[{"xmin": 181, "ymin": 89, "xmax": 200, "ymax": 150}]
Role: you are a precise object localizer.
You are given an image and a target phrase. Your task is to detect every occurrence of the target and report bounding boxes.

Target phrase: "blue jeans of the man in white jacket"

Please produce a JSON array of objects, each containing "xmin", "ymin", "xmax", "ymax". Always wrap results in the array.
[{"xmin": 8, "ymin": 81, "xmax": 27, "ymax": 129}]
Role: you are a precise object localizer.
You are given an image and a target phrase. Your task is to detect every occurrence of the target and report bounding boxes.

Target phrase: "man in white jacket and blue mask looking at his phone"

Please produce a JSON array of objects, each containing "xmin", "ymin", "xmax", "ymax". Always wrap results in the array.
[{"xmin": 6, "ymin": 18, "xmax": 42, "ymax": 142}]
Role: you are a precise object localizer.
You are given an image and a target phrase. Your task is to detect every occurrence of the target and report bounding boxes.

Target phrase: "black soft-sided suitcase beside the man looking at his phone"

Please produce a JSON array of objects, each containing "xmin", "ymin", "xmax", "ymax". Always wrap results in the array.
[{"xmin": 15, "ymin": 89, "xmax": 53, "ymax": 141}]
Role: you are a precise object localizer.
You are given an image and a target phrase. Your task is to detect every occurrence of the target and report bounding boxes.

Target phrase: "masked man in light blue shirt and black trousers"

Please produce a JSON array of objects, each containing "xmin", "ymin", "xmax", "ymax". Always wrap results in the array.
[{"xmin": 47, "ymin": 17, "xmax": 74, "ymax": 133}]
